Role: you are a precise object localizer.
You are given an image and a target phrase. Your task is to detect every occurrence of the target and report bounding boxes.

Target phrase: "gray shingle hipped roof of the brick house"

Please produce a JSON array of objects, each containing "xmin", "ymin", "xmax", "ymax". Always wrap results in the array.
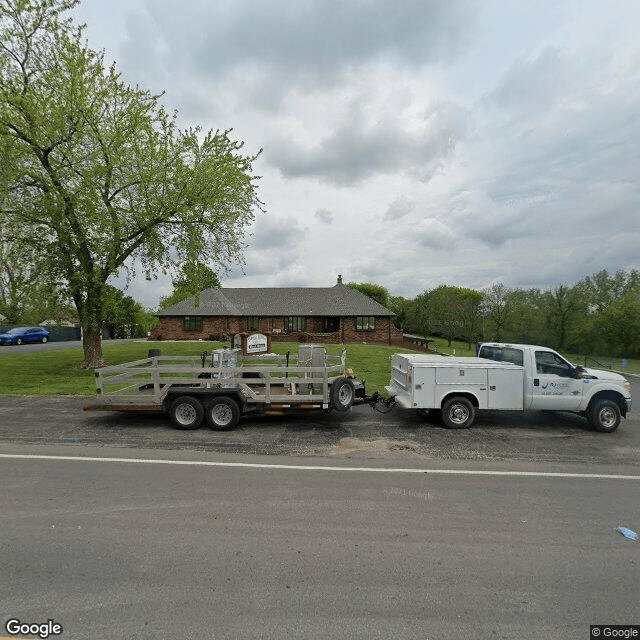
[{"xmin": 158, "ymin": 284, "xmax": 394, "ymax": 317}]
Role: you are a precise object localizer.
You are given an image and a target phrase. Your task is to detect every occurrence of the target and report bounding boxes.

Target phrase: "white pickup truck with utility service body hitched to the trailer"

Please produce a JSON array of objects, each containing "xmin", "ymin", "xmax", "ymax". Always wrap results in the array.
[{"xmin": 385, "ymin": 343, "xmax": 631, "ymax": 433}]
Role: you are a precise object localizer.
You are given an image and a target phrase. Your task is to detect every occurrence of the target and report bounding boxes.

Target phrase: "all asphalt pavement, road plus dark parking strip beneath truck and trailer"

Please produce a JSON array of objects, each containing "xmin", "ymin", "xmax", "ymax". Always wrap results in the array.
[{"xmin": 0, "ymin": 380, "xmax": 640, "ymax": 640}]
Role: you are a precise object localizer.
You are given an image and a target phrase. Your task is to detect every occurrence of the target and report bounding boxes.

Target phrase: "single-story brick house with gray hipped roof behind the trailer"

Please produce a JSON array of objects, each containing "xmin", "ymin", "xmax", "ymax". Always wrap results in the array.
[{"xmin": 149, "ymin": 276, "xmax": 403, "ymax": 345}]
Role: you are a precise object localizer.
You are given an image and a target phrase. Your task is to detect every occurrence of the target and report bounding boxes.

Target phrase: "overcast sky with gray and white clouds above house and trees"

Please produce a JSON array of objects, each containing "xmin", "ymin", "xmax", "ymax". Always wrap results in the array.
[{"xmin": 76, "ymin": 0, "xmax": 640, "ymax": 307}]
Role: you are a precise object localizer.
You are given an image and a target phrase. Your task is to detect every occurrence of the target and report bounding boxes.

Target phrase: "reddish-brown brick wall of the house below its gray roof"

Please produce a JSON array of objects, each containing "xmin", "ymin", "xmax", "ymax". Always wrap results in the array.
[{"xmin": 149, "ymin": 316, "xmax": 403, "ymax": 346}]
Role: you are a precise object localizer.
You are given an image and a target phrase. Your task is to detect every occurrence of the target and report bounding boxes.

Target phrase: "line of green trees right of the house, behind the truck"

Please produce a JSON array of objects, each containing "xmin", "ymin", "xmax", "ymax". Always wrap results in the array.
[{"xmin": 350, "ymin": 270, "xmax": 640, "ymax": 357}]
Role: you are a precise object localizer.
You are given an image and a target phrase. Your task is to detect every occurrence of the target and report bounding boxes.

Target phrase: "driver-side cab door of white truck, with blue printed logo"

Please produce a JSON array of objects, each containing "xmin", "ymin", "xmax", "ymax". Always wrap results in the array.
[{"xmin": 530, "ymin": 351, "xmax": 584, "ymax": 411}]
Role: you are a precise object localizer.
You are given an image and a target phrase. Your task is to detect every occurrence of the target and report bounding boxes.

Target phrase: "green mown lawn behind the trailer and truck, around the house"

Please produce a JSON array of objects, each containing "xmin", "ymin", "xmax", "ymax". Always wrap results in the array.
[{"xmin": 0, "ymin": 339, "xmax": 640, "ymax": 396}]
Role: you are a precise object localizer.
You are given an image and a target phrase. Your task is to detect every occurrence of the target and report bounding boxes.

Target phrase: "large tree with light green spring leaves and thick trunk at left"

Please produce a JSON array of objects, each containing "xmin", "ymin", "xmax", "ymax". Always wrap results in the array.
[{"xmin": 0, "ymin": 0, "xmax": 260, "ymax": 366}]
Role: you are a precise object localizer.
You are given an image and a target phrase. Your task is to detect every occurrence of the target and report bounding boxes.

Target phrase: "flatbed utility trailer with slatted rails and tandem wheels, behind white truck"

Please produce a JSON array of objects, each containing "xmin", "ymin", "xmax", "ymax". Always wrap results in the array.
[{"xmin": 84, "ymin": 345, "xmax": 365, "ymax": 430}]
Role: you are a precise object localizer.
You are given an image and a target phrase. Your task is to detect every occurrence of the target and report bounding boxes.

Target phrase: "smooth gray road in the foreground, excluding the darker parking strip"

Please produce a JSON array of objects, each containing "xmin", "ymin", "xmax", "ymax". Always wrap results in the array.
[{"xmin": 0, "ymin": 443, "xmax": 640, "ymax": 640}]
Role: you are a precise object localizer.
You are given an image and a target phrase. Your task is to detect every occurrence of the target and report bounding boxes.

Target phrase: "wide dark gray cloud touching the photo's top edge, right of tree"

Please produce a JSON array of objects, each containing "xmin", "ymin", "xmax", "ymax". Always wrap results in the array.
[{"xmin": 178, "ymin": 0, "xmax": 475, "ymax": 80}]
